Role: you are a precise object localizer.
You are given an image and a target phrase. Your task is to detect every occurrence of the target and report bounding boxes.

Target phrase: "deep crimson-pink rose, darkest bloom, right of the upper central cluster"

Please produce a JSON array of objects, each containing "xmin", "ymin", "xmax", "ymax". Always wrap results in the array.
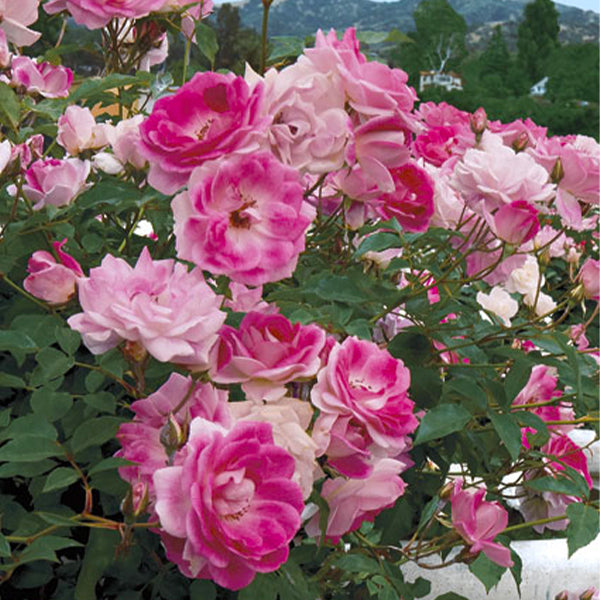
[{"xmin": 377, "ymin": 162, "xmax": 434, "ymax": 231}]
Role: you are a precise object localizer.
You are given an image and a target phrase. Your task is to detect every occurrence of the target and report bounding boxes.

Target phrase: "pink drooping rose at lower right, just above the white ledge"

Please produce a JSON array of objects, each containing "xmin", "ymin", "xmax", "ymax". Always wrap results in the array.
[{"xmin": 451, "ymin": 479, "xmax": 513, "ymax": 567}]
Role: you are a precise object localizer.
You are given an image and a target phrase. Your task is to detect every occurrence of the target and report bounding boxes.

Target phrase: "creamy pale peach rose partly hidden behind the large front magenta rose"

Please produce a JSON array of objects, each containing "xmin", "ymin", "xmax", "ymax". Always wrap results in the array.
[{"xmin": 229, "ymin": 397, "xmax": 323, "ymax": 499}]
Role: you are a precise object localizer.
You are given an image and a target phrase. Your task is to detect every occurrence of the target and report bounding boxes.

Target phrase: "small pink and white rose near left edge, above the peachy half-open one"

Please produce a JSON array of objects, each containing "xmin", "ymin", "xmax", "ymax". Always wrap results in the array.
[{"xmin": 11, "ymin": 56, "xmax": 73, "ymax": 98}]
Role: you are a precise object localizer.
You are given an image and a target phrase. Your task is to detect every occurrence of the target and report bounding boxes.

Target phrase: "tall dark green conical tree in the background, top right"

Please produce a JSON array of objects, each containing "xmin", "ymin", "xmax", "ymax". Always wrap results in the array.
[{"xmin": 517, "ymin": 0, "xmax": 559, "ymax": 83}]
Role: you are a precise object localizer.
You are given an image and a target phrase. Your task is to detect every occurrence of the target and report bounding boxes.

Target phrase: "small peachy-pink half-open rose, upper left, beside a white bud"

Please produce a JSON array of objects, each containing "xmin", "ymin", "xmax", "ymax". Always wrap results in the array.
[{"xmin": 56, "ymin": 105, "xmax": 110, "ymax": 156}]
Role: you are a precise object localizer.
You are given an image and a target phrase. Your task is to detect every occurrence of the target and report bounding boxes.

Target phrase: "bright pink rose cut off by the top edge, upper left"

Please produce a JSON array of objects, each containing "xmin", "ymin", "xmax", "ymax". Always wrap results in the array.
[{"xmin": 44, "ymin": 0, "xmax": 165, "ymax": 29}]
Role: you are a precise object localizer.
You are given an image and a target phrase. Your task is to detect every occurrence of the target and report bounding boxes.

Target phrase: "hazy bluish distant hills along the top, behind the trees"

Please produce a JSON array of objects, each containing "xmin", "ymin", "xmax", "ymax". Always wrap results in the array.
[{"xmin": 234, "ymin": 0, "xmax": 599, "ymax": 48}]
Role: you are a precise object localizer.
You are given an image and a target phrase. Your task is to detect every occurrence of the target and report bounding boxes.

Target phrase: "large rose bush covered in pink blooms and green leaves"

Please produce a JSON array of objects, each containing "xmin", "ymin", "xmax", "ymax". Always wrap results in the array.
[{"xmin": 0, "ymin": 0, "xmax": 600, "ymax": 600}]
